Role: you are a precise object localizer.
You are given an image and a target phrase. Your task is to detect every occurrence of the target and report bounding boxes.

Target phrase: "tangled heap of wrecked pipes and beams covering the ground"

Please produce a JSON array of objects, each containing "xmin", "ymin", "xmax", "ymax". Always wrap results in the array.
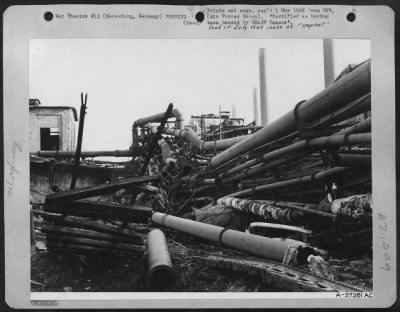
[{"xmin": 30, "ymin": 60, "xmax": 372, "ymax": 291}]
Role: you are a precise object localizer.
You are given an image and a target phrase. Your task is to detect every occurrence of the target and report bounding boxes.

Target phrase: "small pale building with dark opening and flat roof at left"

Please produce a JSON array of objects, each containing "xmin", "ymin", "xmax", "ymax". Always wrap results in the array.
[{"xmin": 29, "ymin": 99, "xmax": 78, "ymax": 152}]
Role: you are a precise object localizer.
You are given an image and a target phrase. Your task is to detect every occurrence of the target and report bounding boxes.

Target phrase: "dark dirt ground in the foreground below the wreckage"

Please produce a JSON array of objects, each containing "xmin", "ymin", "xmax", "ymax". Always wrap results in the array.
[{"xmin": 31, "ymin": 231, "xmax": 372, "ymax": 292}]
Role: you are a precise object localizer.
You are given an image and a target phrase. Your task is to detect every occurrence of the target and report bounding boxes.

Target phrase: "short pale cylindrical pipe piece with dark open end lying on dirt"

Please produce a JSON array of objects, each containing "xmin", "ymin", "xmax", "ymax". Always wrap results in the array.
[{"xmin": 147, "ymin": 229, "xmax": 173, "ymax": 289}]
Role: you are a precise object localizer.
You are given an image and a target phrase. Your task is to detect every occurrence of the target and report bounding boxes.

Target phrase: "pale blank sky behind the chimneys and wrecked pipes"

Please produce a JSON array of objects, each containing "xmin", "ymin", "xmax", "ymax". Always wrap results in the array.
[{"xmin": 29, "ymin": 39, "xmax": 370, "ymax": 150}]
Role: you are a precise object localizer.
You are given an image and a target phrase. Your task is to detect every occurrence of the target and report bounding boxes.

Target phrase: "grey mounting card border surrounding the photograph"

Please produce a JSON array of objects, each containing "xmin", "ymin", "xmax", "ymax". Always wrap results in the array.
[{"xmin": 3, "ymin": 5, "xmax": 397, "ymax": 309}]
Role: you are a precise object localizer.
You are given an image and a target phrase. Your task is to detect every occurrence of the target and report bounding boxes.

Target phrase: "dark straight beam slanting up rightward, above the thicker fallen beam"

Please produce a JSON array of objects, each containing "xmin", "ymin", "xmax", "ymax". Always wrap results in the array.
[{"xmin": 46, "ymin": 176, "xmax": 159, "ymax": 204}]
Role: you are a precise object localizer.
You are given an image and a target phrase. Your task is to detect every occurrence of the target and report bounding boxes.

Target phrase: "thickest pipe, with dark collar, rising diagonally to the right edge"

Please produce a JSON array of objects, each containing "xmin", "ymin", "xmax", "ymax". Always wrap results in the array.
[{"xmin": 210, "ymin": 60, "xmax": 371, "ymax": 168}]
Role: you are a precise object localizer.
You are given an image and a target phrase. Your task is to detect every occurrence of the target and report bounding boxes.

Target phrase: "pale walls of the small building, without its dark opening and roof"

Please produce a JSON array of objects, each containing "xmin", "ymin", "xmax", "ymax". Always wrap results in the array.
[{"xmin": 29, "ymin": 106, "xmax": 76, "ymax": 152}]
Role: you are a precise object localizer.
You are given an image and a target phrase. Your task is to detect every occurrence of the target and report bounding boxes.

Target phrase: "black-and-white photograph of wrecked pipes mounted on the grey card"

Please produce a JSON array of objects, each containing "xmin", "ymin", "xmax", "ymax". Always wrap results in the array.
[{"xmin": 29, "ymin": 39, "xmax": 372, "ymax": 292}]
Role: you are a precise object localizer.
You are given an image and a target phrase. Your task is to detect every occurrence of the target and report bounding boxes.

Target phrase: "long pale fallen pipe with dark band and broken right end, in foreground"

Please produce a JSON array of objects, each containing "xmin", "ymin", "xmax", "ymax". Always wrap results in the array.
[{"xmin": 152, "ymin": 212, "xmax": 315, "ymax": 264}]
